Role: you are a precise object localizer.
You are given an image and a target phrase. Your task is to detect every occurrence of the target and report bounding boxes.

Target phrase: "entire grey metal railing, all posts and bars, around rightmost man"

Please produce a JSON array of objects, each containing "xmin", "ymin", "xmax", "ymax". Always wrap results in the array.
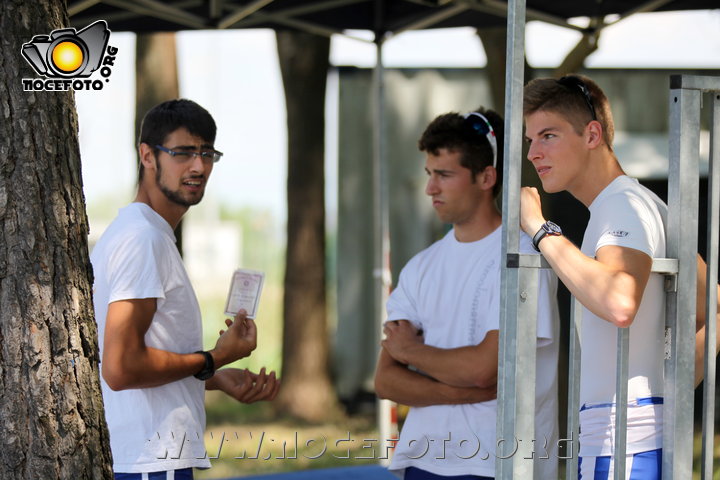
[{"xmin": 496, "ymin": 10, "xmax": 720, "ymax": 472}]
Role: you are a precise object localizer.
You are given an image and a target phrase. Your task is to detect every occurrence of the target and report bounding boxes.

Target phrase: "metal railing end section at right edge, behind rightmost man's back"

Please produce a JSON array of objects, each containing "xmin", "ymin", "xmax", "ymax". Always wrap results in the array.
[{"xmin": 663, "ymin": 75, "xmax": 720, "ymax": 480}]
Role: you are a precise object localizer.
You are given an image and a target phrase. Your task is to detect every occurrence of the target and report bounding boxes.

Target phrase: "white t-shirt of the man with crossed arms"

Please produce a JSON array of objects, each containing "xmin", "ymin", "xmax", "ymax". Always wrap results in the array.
[{"xmin": 387, "ymin": 228, "xmax": 558, "ymax": 479}]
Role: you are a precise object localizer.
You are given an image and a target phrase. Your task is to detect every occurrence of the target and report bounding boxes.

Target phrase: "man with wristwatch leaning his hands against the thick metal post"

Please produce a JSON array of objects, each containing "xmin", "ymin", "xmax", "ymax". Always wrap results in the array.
[{"xmin": 521, "ymin": 75, "xmax": 667, "ymax": 480}]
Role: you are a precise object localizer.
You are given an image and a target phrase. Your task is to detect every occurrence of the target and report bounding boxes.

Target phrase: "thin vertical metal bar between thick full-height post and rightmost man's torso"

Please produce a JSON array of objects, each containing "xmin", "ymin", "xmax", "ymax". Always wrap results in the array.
[{"xmin": 565, "ymin": 296, "xmax": 582, "ymax": 480}]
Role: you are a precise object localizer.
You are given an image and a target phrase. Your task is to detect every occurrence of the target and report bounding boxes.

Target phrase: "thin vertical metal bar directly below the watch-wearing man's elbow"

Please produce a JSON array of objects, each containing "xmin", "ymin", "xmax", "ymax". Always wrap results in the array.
[{"xmin": 613, "ymin": 327, "xmax": 630, "ymax": 480}]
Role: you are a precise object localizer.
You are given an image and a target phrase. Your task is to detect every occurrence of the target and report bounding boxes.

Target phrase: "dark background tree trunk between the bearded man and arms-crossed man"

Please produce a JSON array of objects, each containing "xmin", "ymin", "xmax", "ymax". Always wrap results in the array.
[{"xmin": 277, "ymin": 31, "xmax": 337, "ymax": 421}]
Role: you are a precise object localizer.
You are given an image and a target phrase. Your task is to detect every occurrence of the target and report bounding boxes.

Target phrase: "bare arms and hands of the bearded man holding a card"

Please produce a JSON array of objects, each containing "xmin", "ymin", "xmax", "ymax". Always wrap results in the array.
[{"xmin": 101, "ymin": 298, "xmax": 279, "ymax": 403}]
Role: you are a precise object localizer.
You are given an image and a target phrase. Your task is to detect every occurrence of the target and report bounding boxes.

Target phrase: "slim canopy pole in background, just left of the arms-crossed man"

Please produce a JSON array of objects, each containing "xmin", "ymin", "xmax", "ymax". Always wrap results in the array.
[{"xmin": 372, "ymin": 30, "xmax": 394, "ymax": 466}]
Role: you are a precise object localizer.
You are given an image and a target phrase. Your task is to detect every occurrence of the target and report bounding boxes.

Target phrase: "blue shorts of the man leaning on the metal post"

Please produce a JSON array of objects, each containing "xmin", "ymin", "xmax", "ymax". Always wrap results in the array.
[{"xmin": 578, "ymin": 448, "xmax": 662, "ymax": 480}]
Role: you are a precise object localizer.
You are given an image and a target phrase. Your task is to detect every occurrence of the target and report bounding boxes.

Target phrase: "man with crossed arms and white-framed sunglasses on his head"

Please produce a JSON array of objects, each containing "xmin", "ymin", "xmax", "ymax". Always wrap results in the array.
[{"xmin": 375, "ymin": 109, "xmax": 558, "ymax": 480}]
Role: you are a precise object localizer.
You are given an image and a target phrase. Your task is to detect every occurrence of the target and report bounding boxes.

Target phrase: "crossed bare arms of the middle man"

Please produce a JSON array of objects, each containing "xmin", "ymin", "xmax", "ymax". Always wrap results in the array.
[{"xmin": 375, "ymin": 320, "xmax": 498, "ymax": 407}]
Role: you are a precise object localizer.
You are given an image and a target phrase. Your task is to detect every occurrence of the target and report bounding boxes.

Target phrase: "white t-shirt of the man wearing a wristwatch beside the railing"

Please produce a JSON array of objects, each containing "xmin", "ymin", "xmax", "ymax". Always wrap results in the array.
[{"xmin": 580, "ymin": 175, "xmax": 667, "ymax": 456}]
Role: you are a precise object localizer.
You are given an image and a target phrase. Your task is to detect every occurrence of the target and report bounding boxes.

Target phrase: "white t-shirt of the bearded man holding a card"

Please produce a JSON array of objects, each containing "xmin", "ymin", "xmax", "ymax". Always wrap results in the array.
[{"xmin": 90, "ymin": 203, "xmax": 210, "ymax": 473}]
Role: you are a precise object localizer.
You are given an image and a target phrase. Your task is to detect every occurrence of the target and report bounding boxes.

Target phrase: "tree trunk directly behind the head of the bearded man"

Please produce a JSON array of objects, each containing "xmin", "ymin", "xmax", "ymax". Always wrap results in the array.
[{"xmin": 135, "ymin": 32, "xmax": 183, "ymax": 251}]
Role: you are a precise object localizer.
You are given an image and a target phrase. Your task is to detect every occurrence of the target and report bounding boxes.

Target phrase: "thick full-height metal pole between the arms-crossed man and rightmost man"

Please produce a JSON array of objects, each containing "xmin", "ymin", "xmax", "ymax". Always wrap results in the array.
[{"xmin": 495, "ymin": 0, "xmax": 540, "ymax": 480}]
